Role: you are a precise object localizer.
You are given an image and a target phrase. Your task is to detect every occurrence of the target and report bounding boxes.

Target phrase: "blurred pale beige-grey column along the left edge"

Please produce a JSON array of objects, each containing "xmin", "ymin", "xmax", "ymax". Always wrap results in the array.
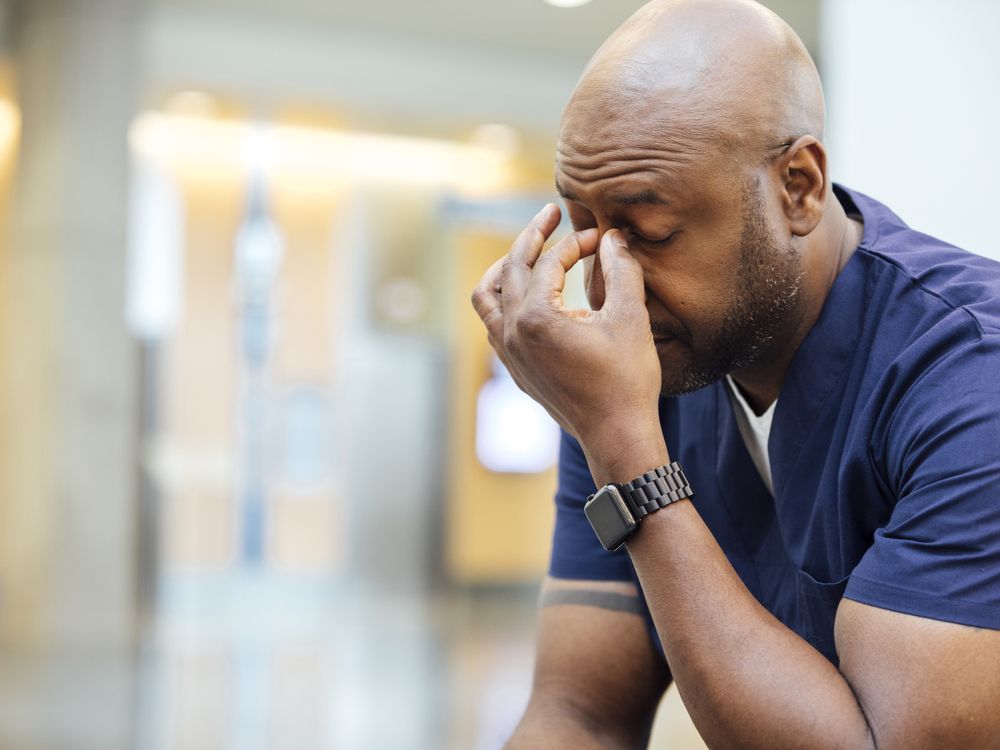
[{"xmin": 0, "ymin": 0, "xmax": 137, "ymax": 652}]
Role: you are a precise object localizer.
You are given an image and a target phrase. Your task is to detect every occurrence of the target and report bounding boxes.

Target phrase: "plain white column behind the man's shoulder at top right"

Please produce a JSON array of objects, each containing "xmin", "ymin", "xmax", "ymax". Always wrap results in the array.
[{"xmin": 821, "ymin": 0, "xmax": 1000, "ymax": 259}]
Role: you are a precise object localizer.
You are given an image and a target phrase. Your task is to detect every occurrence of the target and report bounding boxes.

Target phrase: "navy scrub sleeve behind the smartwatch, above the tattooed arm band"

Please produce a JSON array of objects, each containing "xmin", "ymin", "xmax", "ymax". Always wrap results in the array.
[{"xmin": 549, "ymin": 432, "xmax": 632, "ymax": 581}]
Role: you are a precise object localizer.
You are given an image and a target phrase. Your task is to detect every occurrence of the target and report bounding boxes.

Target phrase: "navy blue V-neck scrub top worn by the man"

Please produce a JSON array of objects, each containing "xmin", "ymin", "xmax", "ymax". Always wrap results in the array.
[{"xmin": 549, "ymin": 186, "xmax": 1000, "ymax": 664}]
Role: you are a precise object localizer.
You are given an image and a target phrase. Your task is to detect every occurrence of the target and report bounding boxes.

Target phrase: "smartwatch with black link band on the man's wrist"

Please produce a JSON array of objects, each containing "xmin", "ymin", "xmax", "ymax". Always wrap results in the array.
[{"xmin": 583, "ymin": 461, "xmax": 694, "ymax": 552}]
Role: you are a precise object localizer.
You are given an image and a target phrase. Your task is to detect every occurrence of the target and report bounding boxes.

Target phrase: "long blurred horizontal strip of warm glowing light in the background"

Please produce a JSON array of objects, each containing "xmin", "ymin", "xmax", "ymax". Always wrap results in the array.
[{"xmin": 129, "ymin": 112, "xmax": 509, "ymax": 192}]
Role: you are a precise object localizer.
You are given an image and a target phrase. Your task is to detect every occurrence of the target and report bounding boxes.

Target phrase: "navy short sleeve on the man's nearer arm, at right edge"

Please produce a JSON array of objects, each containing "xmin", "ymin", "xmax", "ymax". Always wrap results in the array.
[{"xmin": 844, "ymin": 334, "xmax": 1000, "ymax": 630}]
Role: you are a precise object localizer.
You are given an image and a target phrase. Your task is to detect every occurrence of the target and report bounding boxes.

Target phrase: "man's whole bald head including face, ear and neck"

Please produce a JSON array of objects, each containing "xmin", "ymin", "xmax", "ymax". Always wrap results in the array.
[{"xmin": 555, "ymin": 0, "xmax": 860, "ymax": 404}]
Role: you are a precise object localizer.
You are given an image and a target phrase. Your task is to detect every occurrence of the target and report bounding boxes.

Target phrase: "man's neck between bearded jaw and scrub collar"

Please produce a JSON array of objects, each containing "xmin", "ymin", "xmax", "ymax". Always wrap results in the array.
[{"xmin": 732, "ymin": 195, "xmax": 864, "ymax": 416}]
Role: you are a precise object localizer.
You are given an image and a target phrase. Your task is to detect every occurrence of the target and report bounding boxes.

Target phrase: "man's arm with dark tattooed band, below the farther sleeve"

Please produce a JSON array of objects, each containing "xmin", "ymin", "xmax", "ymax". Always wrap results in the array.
[{"xmin": 507, "ymin": 578, "xmax": 670, "ymax": 750}]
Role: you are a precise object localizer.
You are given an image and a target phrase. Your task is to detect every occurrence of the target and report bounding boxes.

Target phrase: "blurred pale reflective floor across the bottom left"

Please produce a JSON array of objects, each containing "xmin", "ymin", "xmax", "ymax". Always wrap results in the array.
[{"xmin": 0, "ymin": 576, "xmax": 701, "ymax": 750}]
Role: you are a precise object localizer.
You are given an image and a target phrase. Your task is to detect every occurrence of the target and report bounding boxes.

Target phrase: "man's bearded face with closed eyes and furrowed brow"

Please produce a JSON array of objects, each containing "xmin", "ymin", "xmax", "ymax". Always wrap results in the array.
[{"xmin": 556, "ymin": 117, "xmax": 803, "ymax": 396}]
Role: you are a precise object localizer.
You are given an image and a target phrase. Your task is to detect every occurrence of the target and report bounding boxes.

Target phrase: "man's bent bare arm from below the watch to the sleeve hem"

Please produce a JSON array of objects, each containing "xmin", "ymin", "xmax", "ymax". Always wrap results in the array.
[{"xmin": 612, "ymin": 468, "xmax": 1000, "ymax": 750}]
